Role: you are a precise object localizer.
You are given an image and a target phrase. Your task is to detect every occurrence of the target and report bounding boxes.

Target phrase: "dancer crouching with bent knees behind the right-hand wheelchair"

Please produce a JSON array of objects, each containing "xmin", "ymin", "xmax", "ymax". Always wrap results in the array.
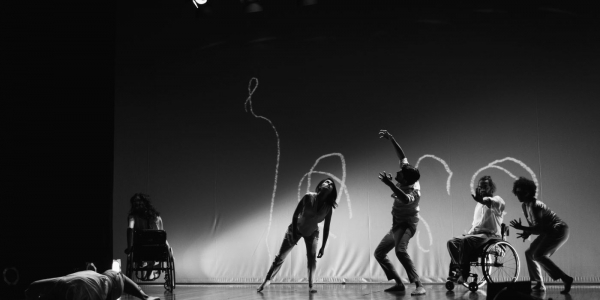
[{"xmin": 510, "ymin": 177, "xmax": 573, "ymax": 294}]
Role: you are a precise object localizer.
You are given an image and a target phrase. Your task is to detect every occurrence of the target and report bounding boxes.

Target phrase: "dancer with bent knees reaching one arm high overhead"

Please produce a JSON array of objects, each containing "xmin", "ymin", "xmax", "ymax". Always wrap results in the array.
[{"xmin": 374, "ymin": 130, "xmax": 426, "ymax": 296}]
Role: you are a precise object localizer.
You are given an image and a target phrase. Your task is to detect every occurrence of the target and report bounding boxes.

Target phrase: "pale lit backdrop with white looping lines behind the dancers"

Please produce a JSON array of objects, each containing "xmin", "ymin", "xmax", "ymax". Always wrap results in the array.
[{"xmin": 113, "ymin": 19, "xmax": 600, "ymax": 283}]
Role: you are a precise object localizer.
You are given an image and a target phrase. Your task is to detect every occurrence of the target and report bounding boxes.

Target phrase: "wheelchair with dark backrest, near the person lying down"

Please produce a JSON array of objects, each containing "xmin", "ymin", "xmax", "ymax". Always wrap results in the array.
[{"xmin": 125, "ymin": 230, "xmax": 176, "ymax": 292}]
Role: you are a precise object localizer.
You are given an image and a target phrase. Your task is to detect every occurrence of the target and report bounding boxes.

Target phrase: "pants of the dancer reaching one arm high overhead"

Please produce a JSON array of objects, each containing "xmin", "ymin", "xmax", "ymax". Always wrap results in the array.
[{"xmin": 374, "ymin": 226, "xmax": 419, "ymax": 282}]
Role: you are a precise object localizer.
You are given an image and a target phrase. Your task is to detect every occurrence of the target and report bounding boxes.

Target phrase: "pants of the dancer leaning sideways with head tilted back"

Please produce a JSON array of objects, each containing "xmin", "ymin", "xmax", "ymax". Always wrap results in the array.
[{"xmin": 266, "ymin": 225, "xmax": 319, "ymax": 287}]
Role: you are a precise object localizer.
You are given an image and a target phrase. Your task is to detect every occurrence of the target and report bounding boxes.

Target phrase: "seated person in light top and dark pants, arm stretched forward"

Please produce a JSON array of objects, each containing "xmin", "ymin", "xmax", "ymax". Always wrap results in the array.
[{"xmin": 447, "ymin": 176, "xmax": 506, "ymax": 283}]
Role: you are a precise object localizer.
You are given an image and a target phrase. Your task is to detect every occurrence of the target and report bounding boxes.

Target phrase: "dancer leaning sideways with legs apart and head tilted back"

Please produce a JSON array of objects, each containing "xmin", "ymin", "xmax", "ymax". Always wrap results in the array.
[{"xmin": 256, "ymin": 178, "xmax": 337, "ymax": 293}]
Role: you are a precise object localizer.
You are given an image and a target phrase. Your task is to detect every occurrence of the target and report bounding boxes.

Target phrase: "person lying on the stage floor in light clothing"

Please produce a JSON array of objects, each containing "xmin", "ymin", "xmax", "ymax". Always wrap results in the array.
[{"xmin": 25, "ymin": 270, "xmax": 160, "ymax": 300}]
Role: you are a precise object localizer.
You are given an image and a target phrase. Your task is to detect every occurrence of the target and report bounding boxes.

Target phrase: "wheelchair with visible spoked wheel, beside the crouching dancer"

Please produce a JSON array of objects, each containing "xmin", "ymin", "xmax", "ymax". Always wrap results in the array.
[{"xmin": 446, "ymin": 224, "xmax": 520, "ymax": 292}]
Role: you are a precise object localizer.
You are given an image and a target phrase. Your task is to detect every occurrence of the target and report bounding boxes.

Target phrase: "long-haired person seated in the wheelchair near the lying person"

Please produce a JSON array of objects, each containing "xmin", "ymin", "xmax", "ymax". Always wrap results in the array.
[{"xmin": 125, "ymin": 193, "xmax": 172, "ymax": 280}]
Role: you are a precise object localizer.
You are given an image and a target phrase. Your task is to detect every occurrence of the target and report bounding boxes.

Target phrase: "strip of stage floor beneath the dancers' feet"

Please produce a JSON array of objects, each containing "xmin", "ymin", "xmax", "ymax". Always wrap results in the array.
[{"xmin": 121, "ymin": 284, "xmax": 600, "ymax": 300}]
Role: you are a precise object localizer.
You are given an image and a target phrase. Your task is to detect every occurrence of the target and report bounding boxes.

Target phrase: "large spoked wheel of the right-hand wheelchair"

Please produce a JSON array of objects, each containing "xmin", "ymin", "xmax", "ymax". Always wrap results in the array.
[{"xmin": 481, "ymin": 241, "xmax": 520, "ymax": 283}]
